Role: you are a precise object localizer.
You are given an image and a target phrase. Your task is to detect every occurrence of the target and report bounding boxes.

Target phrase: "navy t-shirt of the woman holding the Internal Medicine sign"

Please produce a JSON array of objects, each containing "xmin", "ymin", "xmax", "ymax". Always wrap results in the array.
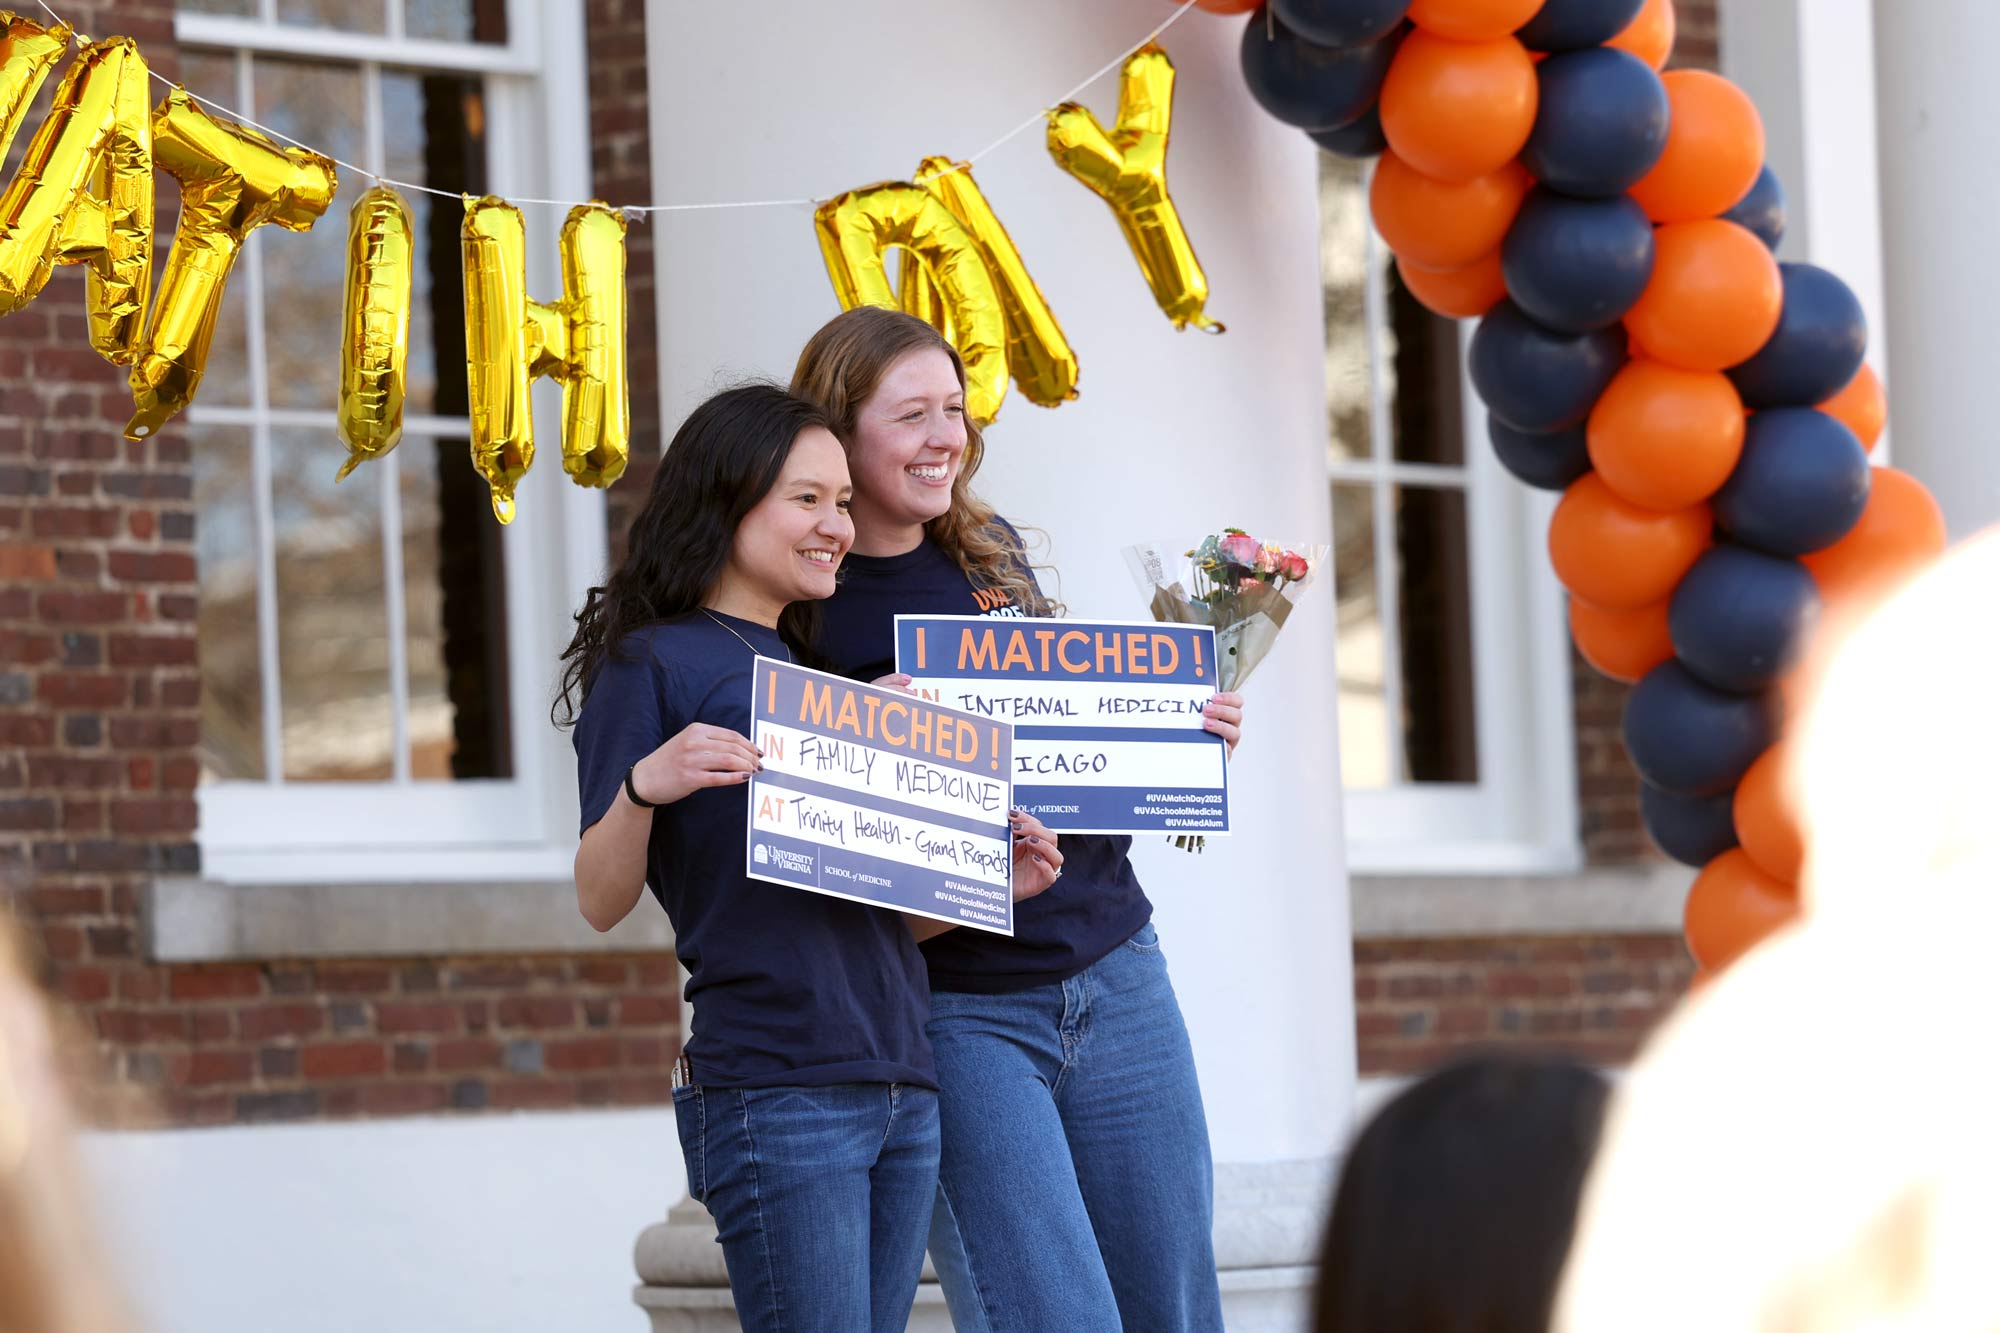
[{"xmin": 818, "ymin": 528, "xmax": 1152, "ymax": 995}]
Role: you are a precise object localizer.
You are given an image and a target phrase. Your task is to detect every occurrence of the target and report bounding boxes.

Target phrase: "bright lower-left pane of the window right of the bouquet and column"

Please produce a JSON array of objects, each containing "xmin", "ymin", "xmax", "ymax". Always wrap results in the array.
[{"xmin": 1334, "ymin": 486, "xmax": 1392, "ymax": 789}]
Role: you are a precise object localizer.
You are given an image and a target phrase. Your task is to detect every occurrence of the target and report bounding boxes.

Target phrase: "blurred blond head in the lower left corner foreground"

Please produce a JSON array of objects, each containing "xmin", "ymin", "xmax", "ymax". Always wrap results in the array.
[{"xmin": 0, "ymin": 909, "xmax": 130, "ymax": 1333}]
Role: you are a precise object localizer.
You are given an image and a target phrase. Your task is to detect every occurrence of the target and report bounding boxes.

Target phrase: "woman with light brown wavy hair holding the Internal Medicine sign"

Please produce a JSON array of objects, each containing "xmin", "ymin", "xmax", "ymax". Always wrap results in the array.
[{"xmin": 792, "ymin": 306, "xmax": 1242, "ymax": 1333}]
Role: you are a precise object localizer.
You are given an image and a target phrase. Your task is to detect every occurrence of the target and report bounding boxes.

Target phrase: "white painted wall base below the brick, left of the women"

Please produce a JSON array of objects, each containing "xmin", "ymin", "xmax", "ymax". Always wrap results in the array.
[{"xmin": 84, "ymin": 1109, "xmax": 686, "ymax": 1333}]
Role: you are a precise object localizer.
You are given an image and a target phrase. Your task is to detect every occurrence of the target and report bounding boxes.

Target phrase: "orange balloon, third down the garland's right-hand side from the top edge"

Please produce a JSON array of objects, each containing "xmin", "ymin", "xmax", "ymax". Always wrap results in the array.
[{"xmin": 1626, "ymin": 218, "xmax": 1784, "ymax": 370}]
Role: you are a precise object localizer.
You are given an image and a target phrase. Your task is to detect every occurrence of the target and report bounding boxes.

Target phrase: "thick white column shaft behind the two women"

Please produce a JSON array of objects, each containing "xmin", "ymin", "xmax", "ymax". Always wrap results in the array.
[{"xmin": 646, "ymin": 0, "xmax": 1354, "ymax": 1161}]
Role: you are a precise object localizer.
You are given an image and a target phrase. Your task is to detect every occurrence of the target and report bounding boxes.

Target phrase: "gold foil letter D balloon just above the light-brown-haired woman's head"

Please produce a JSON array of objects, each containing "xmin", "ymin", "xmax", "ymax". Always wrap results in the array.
[{"xmin": 812, "ymin": 180, "xmax": 1008, "ymax": 424}]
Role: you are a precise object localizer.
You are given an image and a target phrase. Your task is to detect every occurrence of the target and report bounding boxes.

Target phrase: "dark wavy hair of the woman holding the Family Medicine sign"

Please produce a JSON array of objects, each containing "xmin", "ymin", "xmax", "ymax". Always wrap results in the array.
[{"xmin": 550, "ymin": 384, "xmax": 832, "ymax": 727}]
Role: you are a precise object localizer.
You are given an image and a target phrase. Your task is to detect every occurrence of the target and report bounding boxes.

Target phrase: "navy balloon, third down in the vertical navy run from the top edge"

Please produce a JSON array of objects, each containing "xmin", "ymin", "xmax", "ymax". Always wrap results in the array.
[{"xmin": 1500, "ymin": 186, "xmax": 1652, "ymax": 332}]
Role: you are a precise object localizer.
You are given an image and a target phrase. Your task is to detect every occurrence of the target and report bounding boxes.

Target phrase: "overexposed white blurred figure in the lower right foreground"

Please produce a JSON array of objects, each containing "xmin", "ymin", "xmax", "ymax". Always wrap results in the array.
[{"xmin": 1556, "ymin": 536, "xmax": 2000, "ymax": 1333}]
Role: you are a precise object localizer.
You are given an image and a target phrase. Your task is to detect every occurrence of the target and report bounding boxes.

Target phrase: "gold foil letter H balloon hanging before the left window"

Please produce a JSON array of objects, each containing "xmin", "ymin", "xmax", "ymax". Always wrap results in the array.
[{"xmin": 460, "ymin": 194, "xmax": 632, "ymax": 522}]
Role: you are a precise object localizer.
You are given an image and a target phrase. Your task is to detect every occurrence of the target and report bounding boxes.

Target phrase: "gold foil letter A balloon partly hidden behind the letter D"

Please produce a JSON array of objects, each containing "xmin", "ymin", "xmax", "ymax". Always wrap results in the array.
[{"xmin": 916, "ymin": 158, "xmax": 1076, "ymax": 406}]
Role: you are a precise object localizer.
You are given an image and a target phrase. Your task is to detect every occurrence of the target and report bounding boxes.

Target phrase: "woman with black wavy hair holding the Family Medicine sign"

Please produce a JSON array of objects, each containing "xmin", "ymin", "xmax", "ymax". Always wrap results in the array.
[{"xmin": 556, "ymin": 384, "xmax": 1060, "ymax": 1333}]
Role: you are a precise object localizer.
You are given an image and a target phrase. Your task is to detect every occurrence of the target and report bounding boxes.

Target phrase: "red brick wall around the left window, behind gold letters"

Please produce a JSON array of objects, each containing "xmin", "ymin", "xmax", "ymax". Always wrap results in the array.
[{"xmin": 0, "ymin": 0, "xmax": 678, "ymax": 1125}]
